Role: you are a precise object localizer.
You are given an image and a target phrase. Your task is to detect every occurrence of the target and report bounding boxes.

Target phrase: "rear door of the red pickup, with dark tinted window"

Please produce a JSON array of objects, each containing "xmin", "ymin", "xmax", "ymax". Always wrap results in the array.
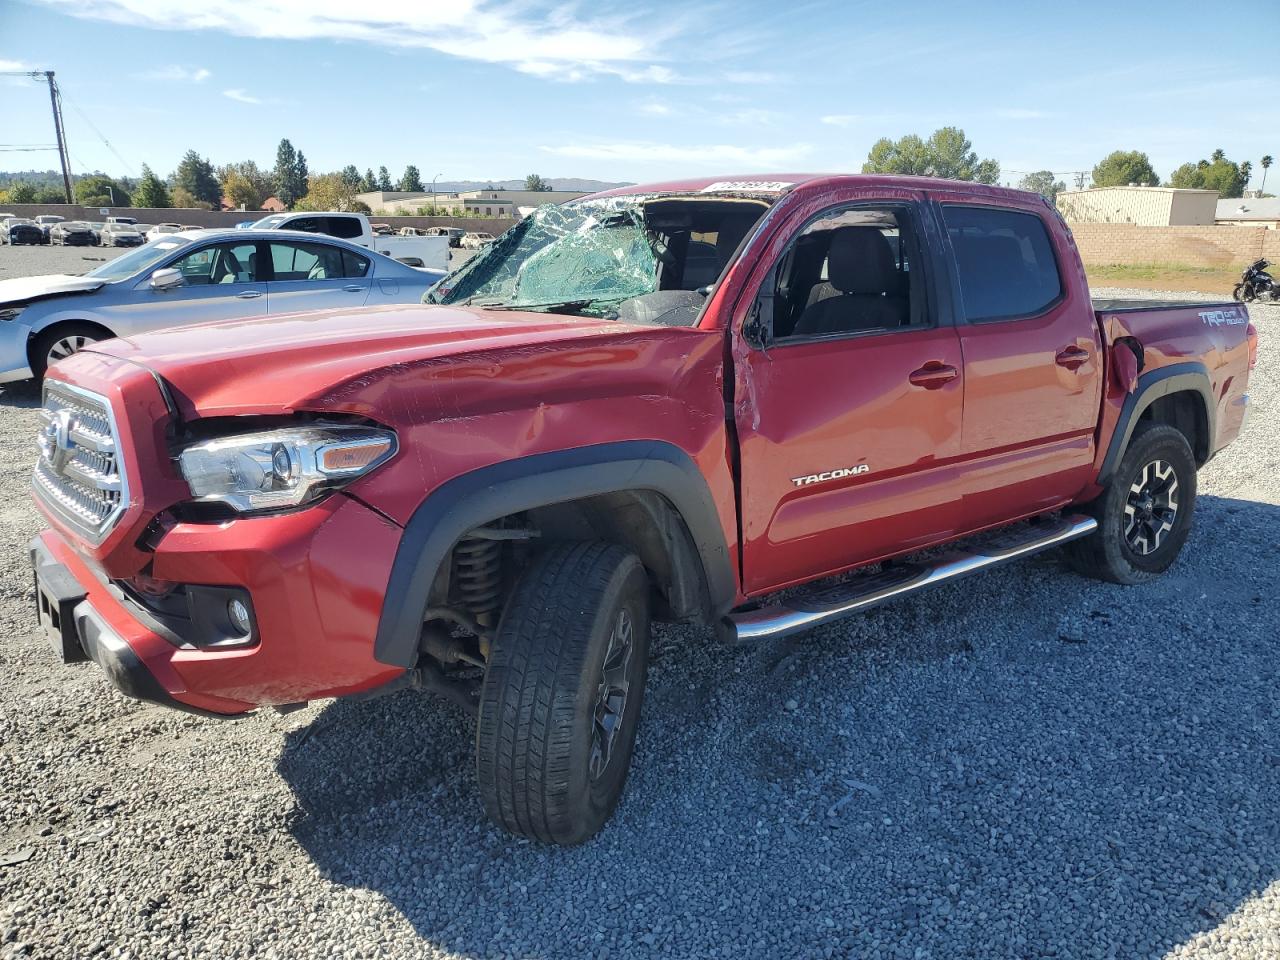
[{"xmin": 936, "ymin": 193, "xmax": 1102, "ymax": 529}]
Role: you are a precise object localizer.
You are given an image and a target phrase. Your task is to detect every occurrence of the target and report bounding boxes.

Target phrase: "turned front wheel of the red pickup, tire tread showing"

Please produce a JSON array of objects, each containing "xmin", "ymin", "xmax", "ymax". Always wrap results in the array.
[{"xmin": 476, "ymin": 541, "xmax": 649, "ymax": 845}]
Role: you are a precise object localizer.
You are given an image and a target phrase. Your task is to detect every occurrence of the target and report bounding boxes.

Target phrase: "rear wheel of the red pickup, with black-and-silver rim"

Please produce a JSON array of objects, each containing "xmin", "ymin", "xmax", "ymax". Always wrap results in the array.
[{"xmin": 1065, "ymin": 424, "xmax": 1196, "ymax": 585}]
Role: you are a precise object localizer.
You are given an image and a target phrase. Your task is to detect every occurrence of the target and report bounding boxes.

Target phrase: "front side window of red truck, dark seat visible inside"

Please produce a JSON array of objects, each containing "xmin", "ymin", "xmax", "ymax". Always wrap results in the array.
[{"xmin": 773, "ymin": 205, "xmax": 931, "ymax": 340}]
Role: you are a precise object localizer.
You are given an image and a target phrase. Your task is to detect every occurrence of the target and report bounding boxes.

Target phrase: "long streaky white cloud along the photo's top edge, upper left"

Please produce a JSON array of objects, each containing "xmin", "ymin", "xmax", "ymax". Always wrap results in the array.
[{"xmin": 27, "ymin": 0, "xmax": 687, "ymax": 83}]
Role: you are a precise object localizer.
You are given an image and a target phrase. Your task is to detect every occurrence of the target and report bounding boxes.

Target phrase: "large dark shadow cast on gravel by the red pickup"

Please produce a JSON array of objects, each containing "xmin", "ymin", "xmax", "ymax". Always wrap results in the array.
[{"xmin": 279, "ymin": 497, "xmax": 1280, "ymax": 957}]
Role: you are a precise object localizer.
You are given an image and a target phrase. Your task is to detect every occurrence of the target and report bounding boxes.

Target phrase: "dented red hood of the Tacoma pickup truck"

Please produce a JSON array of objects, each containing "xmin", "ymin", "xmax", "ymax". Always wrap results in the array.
[{"xmin": 88, "ymin": 305, "xmax": 632, "ymax": 417}]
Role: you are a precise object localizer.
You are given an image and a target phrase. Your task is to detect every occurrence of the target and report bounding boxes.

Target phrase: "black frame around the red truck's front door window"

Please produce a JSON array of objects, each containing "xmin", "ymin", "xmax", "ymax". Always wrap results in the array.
[{"xmin": 747, "ymin": 197, "xmax": 950, "ymax": 349}]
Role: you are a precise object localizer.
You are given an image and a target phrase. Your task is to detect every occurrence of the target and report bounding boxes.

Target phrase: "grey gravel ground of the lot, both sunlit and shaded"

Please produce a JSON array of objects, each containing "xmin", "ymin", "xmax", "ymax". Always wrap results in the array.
[{"xmin": 0, "ymin": 248, "xmax": 1280, "ymax": 960}]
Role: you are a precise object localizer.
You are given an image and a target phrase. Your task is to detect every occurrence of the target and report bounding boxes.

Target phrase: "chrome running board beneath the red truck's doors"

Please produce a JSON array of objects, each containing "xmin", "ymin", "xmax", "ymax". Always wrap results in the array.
[{"xmin": 724, "ymin": 515, "xmax": 1098, "ymax": 644}]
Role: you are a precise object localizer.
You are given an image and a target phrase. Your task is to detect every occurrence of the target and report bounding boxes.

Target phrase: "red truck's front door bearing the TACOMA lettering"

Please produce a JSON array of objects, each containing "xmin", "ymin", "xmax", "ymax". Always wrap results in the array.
[{"xmin": 733, "ymin": 191, "xmax": 964, "ymax": 594}]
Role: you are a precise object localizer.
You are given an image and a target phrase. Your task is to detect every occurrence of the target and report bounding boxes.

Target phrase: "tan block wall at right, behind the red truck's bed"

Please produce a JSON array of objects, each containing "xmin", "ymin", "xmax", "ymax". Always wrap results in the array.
[{"xmin": 1071, "ymin": 223, "xmax": 1280, "ymax": 268}]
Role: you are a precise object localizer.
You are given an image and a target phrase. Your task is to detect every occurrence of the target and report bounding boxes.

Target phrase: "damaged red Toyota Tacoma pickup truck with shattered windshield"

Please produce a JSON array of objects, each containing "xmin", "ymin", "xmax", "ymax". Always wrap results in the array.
[{"xmin": 31, "ymin": 174, "xmax": 1257, "ymax": 844}]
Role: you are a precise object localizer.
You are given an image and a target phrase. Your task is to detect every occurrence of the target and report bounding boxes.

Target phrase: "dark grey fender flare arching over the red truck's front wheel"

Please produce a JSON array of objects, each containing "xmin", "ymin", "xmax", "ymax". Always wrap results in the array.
[{"xmin": 374, "ymin": 440, "xmax": 737, "ymax": 668}]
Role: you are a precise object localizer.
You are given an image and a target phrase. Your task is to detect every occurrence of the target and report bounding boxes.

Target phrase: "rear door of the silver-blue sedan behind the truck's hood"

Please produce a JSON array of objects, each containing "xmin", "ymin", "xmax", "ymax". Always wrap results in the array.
[{"xmin": 266, "ymin": 239, "xmax": 372, "ymax": 314}]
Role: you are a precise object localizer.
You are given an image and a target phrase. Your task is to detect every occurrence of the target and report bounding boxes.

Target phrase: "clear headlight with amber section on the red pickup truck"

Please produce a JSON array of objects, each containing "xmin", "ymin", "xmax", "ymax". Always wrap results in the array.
[{"xmin": 178, "ymin": 424, "xmax": 396, "ymax": 513}]
